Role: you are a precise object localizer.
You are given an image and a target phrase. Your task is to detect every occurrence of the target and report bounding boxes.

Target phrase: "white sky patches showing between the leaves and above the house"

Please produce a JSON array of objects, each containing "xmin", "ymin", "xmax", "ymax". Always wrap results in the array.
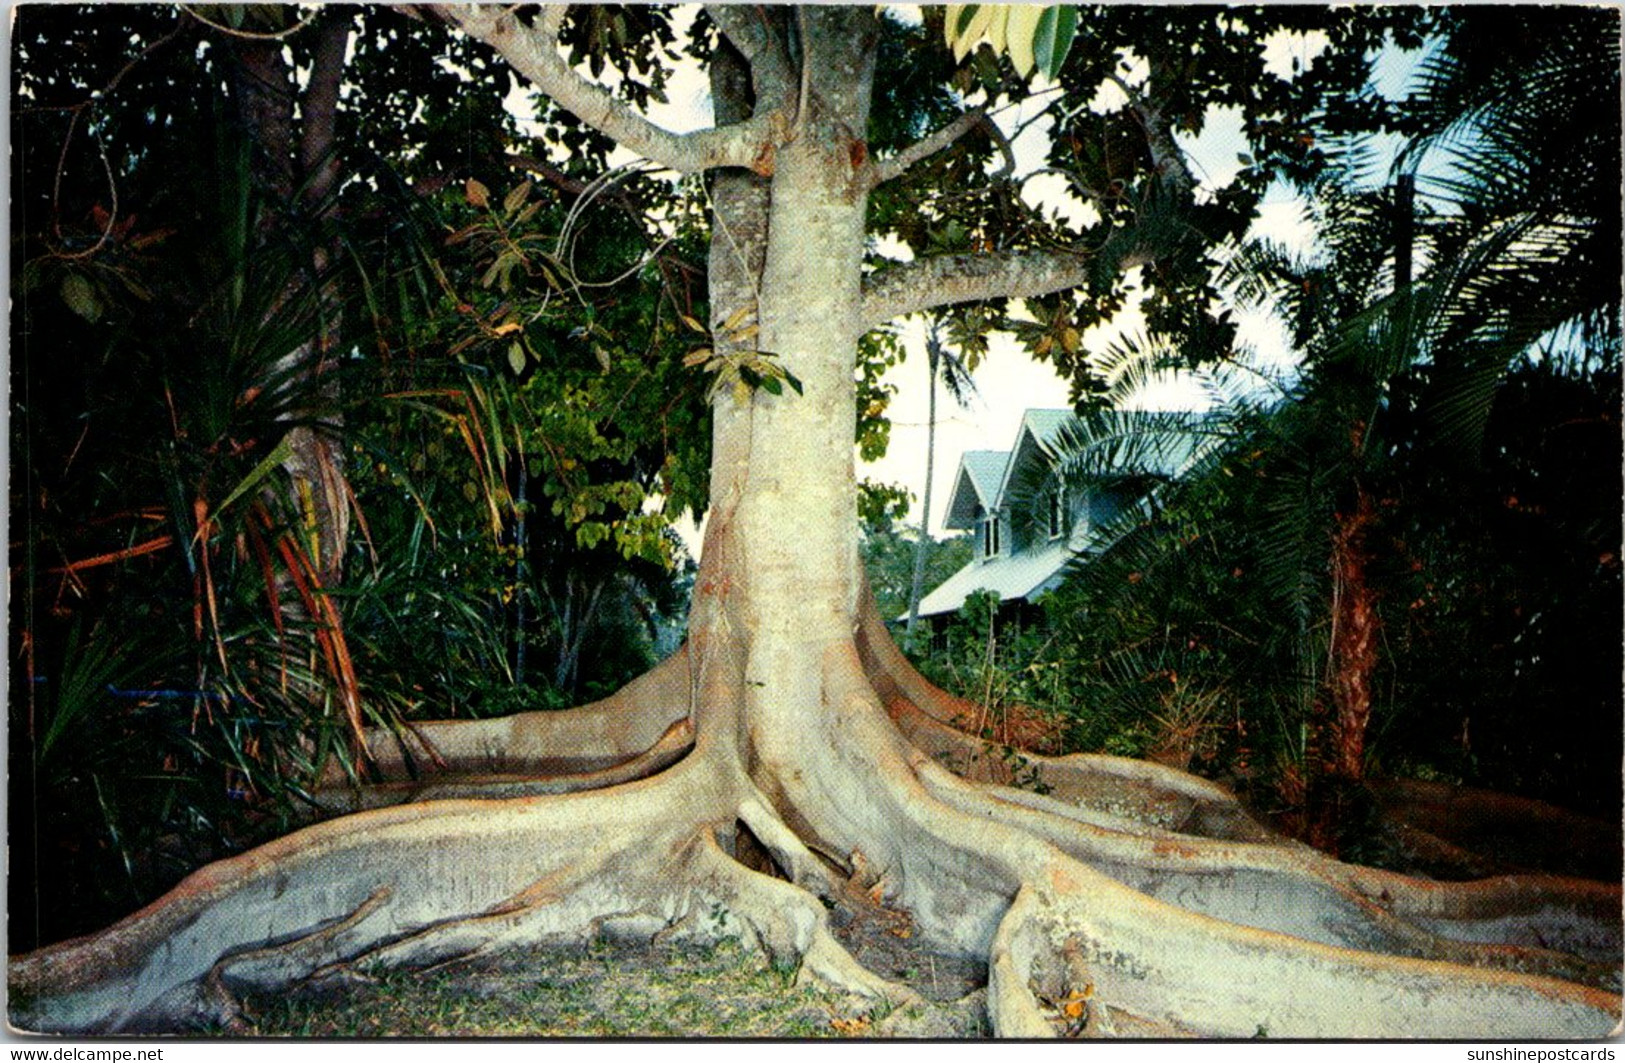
[{"xmin": 509, "ymin": 15, "xmax": 1415, "ymax": 558}]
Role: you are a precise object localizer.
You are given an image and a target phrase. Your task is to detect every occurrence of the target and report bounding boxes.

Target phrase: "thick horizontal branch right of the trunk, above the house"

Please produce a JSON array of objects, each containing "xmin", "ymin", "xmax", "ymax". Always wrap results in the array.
[{"xmin": 863, "ymin": 250, "xmax": 1149, "ymax": 330}]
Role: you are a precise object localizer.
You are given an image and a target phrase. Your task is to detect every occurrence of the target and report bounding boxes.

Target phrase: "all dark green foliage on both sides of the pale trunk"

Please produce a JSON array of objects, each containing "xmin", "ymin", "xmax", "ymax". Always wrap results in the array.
[{"xmin": 8, "ymin": 5, "xmax": 1620, "ymax": 981}]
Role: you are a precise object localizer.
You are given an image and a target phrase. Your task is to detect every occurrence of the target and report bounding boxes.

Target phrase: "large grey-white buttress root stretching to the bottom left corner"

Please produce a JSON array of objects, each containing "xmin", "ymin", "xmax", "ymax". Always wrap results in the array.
[{"xmin": 11, "ymin": 741, "xmax": 920, "ymax": 1030}]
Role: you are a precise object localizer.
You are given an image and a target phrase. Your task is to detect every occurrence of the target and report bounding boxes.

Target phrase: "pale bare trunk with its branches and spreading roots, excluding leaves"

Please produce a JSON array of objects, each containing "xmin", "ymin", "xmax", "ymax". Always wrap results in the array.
[{"xmin": 11, "ymin": 8, "xmax": 1620, "ymax": 1039}]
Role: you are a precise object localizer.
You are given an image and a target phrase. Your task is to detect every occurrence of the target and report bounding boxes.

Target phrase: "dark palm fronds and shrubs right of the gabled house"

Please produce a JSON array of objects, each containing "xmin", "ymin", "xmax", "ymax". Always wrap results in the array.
[{"xmin": 910, "ymin": 11, "xmax": 1620, "ymax": 857}]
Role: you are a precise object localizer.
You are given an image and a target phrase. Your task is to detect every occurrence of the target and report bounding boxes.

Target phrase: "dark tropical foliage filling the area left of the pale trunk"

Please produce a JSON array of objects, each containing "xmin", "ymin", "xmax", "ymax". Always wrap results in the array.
[{"xmin": 8, "ymin": 7, "xmax": 709, "ymax": 946}]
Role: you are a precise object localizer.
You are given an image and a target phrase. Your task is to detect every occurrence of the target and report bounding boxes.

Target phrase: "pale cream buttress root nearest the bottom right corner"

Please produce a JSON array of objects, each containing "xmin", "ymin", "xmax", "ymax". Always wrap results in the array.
[{"xmin": 995, "ymin": 868, "xmax": 1619, "ymax": 1039}]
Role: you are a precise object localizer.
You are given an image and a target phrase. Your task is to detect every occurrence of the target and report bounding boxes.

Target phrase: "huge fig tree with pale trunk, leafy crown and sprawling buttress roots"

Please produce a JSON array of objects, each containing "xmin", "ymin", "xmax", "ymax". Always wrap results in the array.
[{"xmin": 10, "ymin": 5, "xmax": 1620, "ymax": 1039}]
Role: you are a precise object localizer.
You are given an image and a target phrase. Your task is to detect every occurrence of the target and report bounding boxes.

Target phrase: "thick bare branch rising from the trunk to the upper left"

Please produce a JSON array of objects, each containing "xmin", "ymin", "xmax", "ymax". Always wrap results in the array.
[{"xmin": 432, "ymin": 3, "xmax": 788, "ymax": 174}]
